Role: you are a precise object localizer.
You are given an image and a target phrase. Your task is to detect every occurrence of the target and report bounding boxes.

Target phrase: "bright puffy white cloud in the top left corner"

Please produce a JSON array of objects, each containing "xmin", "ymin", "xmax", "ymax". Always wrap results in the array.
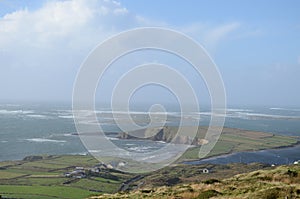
[{"xmin": 0, "ymin": 0, "xmax": 126, "ymax": 41}]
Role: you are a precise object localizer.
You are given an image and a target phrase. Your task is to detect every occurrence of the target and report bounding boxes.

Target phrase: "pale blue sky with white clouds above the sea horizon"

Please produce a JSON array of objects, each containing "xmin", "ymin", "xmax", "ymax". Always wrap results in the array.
[{"xmin": 0, "ymin": 0, "xmax": 300, "ymax": 107}]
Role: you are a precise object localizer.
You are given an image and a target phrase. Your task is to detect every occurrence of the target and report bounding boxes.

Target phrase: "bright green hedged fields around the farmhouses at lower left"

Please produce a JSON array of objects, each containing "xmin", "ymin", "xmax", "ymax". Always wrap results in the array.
[{"xmin": 0, "ymin": 155, "xmax": 132, "ymax": 199}]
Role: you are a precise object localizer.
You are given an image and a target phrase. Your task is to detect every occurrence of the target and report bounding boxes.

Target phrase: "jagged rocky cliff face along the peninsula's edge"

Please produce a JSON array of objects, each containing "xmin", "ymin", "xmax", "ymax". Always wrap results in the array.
[{"xmin": 118, "ymin": 126, "xmax": 208, "ymax": 145}]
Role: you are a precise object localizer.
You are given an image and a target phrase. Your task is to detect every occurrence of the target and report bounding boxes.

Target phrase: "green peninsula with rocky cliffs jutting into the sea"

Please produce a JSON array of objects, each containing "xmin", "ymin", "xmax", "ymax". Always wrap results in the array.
[{"xmin": 118, "ymin": 126, "xmax": 299, "ymax": 161}]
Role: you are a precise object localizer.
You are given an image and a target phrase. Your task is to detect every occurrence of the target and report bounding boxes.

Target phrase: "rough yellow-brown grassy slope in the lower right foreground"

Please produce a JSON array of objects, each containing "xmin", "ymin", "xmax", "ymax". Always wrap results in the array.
[{"xmin": 92, "ymin": 165, "xmax": 300, "ymax": 199}]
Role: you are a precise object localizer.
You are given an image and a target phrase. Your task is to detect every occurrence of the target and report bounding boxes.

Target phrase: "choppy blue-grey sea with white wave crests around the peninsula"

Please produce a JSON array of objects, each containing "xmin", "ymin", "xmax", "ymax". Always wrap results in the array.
[{"xmin": 0, "ymin": 103, "xmax": 300, "ymax": 164}]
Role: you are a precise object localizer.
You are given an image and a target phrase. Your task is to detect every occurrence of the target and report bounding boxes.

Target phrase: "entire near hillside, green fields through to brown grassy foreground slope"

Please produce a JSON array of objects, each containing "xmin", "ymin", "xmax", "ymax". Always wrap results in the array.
[{"xmin": 0, "ymin": 155, "xmax": 300, "ymax": 199}]
